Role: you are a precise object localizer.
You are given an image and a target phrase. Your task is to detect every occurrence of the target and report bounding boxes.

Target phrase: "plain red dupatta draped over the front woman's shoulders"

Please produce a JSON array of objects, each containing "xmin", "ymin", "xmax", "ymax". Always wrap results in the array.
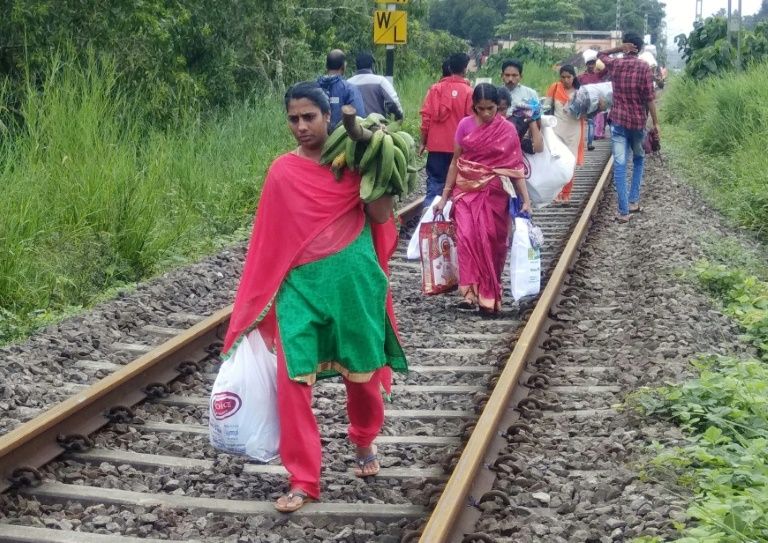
[{"xmin": 222, "ymin": 153, "xmax": 397, "ymax": 382}]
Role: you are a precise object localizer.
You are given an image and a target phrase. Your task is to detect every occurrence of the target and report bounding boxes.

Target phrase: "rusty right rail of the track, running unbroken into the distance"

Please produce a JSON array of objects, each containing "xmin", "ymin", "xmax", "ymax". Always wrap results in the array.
[{"xmin": 419, "ymin": 158, "xmax": 613, "ymax": 543}]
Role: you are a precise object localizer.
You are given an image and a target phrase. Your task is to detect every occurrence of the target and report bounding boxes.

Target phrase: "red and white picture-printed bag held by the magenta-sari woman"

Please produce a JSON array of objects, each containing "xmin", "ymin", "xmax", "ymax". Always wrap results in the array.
[{"xmin": 419, "ymin": 215, "xmax": 459, "ymax": 294}]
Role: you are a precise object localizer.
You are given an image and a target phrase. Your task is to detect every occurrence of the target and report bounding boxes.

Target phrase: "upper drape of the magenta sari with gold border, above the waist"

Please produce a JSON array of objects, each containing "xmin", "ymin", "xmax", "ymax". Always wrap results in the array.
[{"xmin": 456, "ymin": 115, "xmax": 525, "ymax": 192}]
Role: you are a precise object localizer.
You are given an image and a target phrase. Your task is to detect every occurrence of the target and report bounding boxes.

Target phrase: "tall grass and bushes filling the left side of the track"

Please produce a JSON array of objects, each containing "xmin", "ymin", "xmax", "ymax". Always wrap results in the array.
[{"xmin": 0, "ymin": 0, "xmax": 467, "ymax": 344}]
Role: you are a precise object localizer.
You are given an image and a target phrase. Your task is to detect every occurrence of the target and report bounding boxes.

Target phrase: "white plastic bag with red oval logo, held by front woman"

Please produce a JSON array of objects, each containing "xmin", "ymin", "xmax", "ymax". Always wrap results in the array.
[{"xmin": 208, "ymin": 330, "xmax": 280, "ymax": 462}]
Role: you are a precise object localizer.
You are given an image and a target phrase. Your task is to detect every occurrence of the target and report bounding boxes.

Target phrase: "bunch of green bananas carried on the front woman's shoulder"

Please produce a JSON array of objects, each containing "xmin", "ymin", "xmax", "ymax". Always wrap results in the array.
[{"xmin": 320, "ymin": 113, "xmax": 419, "ymax": 202}]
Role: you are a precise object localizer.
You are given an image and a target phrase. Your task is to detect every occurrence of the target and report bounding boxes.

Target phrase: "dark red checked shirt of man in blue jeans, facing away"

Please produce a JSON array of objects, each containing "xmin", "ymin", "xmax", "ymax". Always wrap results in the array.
[{"xmin": 597, "ymin": 53, "xmax": 656, "ymax": 130}]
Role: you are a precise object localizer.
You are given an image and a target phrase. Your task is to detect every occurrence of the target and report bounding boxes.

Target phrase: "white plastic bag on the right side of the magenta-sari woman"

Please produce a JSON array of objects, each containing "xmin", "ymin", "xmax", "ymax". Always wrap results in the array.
[{"xmin": 509, "ymin": 217, "xmax": 541, "ymax": 301}]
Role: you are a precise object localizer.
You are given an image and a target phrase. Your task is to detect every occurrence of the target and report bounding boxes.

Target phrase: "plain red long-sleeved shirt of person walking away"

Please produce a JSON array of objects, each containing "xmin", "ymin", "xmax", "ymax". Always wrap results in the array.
[{"xmin": 421, "ymin": 75, "xmax": 472, "ymax": 153}]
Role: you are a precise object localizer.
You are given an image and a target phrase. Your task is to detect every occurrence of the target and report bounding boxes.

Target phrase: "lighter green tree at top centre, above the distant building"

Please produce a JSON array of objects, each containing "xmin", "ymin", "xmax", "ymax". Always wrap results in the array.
[{"xmin": 496, "ymin": 0, "xmax": 584, "ymax": 38}]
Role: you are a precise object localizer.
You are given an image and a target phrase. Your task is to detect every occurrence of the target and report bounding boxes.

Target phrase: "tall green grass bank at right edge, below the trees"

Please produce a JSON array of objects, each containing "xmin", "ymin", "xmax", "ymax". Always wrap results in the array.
[{"xmin": 662, "ymin": 64, "xmax": 768, "ymax": 240}]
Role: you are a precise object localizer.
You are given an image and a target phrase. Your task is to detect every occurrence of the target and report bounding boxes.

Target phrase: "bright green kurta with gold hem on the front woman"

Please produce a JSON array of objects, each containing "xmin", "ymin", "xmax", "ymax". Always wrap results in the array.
[{"xmin": 276, "ymin": 224, "xmax": 408, "ymax": 384}]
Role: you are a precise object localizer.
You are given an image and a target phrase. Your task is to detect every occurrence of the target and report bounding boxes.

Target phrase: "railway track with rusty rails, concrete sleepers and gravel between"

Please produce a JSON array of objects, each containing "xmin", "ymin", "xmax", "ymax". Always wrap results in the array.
[{"xmin": 0, "ymin": 142, "xmax": 612, "ymax": 543}]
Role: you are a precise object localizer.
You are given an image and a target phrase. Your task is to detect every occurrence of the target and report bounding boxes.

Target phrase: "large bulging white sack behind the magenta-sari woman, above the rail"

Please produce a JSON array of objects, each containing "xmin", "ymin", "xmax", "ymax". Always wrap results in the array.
[{"xmin": 523, "ymin": 126, "xmax": 576, "ymax": 208}]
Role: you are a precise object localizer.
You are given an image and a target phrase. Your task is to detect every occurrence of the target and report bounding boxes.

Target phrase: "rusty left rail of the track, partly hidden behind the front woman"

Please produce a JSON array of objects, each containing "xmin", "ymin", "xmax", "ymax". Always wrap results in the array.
[{"xmin": 0, "ymin": 197, "xmax": 424, "ymax": 492}]
